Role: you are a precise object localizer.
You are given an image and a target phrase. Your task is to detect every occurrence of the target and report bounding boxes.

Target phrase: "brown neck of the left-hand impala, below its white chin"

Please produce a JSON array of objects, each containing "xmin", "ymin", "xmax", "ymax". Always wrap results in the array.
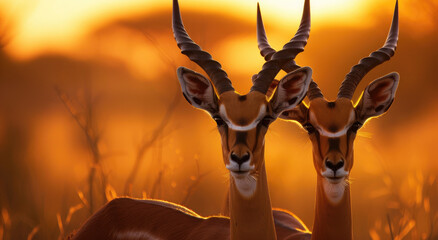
[{"xmin": 229, "ymin": 148, "xmax": 277, "ymax": 240}]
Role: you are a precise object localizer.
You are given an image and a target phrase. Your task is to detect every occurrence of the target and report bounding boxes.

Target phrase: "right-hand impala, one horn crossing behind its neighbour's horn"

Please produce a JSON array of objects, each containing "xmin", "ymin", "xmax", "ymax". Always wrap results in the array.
[{"xmin": 257, "ymin": 1, "xmax": 399, "ymax": 240}]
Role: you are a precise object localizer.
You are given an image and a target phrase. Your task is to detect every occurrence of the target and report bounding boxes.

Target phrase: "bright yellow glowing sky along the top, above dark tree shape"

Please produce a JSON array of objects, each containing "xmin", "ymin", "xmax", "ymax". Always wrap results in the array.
[{"xmin": 0, "ymin": 0, "xmax": 372, "ymax": 59}]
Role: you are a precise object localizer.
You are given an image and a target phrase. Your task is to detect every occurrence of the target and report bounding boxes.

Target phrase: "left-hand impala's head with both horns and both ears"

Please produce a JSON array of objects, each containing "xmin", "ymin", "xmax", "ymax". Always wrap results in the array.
[{"xmin": 173, "ymin": 0, "xmax": 312, "ymax": 197}]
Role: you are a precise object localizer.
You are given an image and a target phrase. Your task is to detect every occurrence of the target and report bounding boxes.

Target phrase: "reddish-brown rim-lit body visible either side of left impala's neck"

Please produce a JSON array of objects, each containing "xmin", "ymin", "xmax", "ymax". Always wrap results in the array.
[{"xmin": 71, "ymin": 198, "xmax": 310, "ymax": 240}]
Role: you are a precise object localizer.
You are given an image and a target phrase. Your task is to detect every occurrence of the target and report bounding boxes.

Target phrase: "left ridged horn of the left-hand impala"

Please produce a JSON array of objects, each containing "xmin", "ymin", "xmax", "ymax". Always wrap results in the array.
[{"xmin": 172, "ymin": 0, "xmax": 234, "ymax": 94}]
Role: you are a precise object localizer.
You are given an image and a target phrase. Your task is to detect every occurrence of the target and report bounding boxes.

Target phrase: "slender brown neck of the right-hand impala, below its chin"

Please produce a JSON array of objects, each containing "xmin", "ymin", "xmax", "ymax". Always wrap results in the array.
[{"xmin": 311, "ymin": 175, "xmax": 353, "ymax": 240}]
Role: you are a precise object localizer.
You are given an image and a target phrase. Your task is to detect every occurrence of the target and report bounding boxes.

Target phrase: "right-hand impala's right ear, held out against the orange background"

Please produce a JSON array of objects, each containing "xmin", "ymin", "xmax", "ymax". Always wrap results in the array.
[{"xmin": 355, "ymin": 73, "xmax": 400, "ymax": 121}]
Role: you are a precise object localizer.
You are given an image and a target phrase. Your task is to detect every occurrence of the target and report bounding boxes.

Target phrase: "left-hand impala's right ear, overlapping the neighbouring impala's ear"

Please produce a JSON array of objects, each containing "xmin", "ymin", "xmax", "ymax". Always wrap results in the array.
[{"xmin": 270, "ymin": 67, "xmax": 312, "ymax": 115}]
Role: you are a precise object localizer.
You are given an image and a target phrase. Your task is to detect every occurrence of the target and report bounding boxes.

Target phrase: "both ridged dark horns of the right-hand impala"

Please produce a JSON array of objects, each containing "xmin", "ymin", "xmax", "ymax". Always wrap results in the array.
[{"xmin": 257, "ymin": 0, "xmax": 398, "ymax": 100}]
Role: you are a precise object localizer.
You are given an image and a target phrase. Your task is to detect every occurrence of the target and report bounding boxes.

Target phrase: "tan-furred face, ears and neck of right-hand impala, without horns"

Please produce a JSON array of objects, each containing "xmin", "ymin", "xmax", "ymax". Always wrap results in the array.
[{"xmin": 282, "ymin": 74, "xmax": 398, "ymax": 240}]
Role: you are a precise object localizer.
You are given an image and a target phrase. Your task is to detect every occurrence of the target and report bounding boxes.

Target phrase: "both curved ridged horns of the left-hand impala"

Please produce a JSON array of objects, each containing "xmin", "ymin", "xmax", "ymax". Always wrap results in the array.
[{"xmin": 172, "ymin": 0, "xmax": 310, "ymax": 94}]
